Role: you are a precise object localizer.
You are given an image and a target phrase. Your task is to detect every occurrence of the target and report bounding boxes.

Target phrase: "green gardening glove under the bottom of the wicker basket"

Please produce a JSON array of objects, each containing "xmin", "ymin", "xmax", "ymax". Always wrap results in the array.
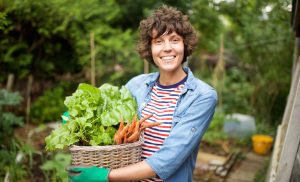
[{"xmin": 68, "ymin": 166, "xmax": 109, "ymax": 182}]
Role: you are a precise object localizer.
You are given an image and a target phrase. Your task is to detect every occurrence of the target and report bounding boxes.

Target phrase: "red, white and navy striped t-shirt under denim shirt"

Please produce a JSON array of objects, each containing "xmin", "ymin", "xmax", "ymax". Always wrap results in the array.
[{"xmin": 141, "ymin": 77, "xmax": 187, "ymax": 181}]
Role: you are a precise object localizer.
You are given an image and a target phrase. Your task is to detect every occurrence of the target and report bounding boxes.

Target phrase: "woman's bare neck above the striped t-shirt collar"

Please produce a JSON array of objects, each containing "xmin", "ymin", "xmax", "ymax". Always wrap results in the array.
[{"xmin": 159, "ymin": 68, "xmax": 187, "ymax": 86}]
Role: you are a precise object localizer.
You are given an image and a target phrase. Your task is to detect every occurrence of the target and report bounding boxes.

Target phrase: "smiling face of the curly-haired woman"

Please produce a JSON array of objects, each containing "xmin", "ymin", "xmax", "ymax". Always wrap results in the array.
[{"xmin": 151, "ymin": 29, "xmax": 184, "ymax": 73}]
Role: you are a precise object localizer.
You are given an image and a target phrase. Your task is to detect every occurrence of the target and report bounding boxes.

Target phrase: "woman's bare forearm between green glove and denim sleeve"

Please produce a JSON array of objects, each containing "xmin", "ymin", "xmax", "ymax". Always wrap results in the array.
[{"xmin": 108, "ymin": 161, "xmax": 156, "ymax": 182}]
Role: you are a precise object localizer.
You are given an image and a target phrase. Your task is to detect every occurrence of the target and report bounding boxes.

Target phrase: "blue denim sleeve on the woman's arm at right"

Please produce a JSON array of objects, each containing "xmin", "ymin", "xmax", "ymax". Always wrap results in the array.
[{"xmin": 146, "ymin": 89, "xmax": 217, "ymax": 180}]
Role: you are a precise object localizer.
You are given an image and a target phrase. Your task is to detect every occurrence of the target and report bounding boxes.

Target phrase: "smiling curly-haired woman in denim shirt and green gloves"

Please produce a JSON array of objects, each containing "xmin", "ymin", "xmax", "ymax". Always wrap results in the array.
[{"xmin": 70, "ymin": 5, "xmax": 217, "ymax": 182}]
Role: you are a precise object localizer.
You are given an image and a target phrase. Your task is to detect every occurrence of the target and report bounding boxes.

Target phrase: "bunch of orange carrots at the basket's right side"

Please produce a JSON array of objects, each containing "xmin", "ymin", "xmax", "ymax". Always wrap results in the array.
[{"xmin": 114, "ymin": 114, "xmax": 161, "ymax": 145}]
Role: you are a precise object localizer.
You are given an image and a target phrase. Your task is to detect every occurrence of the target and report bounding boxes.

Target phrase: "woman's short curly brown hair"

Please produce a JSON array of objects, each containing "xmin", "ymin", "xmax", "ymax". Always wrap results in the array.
[{"xmin": 137, "ymin": 5, "xmax": 198, "ymax": 66}]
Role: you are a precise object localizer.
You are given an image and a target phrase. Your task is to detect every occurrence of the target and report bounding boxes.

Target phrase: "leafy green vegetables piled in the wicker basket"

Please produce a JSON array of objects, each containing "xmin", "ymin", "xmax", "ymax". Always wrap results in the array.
[{"xmin": 45, "ymin": 83, "xmax": 137, "ymax": 150}]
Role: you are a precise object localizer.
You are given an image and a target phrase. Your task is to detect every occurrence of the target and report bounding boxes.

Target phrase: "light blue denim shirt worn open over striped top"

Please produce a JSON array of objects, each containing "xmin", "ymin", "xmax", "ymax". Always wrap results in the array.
[{"xmin": 126, "ymin": 67, "xmax": 217, "ymax": 182}]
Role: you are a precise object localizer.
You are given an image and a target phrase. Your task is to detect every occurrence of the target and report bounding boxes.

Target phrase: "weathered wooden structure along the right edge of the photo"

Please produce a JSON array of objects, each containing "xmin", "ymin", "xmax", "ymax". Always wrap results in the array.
[{"xmin": 266, "ymin": 0, "xmax": 300, "ymax": 182}]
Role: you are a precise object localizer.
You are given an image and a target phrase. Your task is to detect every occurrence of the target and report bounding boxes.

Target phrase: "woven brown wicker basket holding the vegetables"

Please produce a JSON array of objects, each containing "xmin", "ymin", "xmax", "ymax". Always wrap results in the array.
[{"xmin": 69, "ymin": 137, "xmax": 143, "ymax": 169}]
